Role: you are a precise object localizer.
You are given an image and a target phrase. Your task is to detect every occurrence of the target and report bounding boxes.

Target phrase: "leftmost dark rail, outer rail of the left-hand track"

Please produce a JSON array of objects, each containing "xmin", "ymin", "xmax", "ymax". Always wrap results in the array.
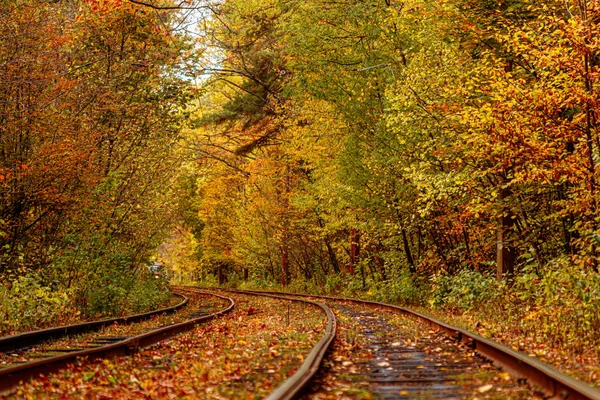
[{"xmin": 0, "ymin": 293, "xmax": 188, "ymax": 353}]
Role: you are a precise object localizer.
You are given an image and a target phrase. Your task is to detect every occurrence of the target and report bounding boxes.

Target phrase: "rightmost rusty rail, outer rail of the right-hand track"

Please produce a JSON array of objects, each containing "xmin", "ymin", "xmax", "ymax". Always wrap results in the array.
[{"xmin": 207, "ymin": 289, "xmax": 600, "ymax": 400}]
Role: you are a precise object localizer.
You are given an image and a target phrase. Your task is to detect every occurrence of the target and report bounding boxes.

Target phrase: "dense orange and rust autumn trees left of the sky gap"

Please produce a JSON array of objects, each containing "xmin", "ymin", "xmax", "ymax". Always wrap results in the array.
[{"xmin": 0, "ymin": 0, "xmax": 195, "ymax": 310}]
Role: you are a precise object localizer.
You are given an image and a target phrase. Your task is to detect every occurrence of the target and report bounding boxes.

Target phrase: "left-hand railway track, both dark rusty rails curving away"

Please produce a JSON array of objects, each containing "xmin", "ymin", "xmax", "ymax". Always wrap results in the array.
[{"xmin": 0, "ymin": 289, "xmax": 234, "ymax": 396}]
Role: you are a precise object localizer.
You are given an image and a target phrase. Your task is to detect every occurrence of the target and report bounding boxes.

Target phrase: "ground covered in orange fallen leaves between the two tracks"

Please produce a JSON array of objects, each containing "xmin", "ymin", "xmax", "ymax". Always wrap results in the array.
[{"xmin": 7, "ymin": 295, "xmax": 326, "ymax": 399}]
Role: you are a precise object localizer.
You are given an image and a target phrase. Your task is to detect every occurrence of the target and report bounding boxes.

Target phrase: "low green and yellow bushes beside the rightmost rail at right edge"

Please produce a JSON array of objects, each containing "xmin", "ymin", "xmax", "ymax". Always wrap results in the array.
[{"xmin": 429, "ymin": 266, "xmax": 600, "ymax": 354}]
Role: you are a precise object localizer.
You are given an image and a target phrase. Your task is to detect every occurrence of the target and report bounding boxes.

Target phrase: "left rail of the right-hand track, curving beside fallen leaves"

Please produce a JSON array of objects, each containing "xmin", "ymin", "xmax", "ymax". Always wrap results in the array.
[{"xmin": 217, "ymin": 289, "xmax": 337, "ymax": 400}]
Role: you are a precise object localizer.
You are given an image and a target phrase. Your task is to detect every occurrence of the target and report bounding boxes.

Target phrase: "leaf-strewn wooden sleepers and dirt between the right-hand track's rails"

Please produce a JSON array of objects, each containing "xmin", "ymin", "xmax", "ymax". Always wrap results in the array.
[{"xmin": 303, "ymin": 305, "xmax": 543, "ymax": 399}]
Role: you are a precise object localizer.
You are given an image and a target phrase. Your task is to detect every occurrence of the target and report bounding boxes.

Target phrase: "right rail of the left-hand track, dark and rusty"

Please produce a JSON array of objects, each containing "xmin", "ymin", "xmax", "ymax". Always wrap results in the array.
[{"xmin": 0, "ymin": 291, "xmax": 235, "ymax": 396}]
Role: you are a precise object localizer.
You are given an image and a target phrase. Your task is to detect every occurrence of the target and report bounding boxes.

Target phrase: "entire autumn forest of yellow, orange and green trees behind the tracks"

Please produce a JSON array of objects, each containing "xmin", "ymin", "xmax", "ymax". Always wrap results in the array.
[{"xmin": 0, "ymin": 0, "xmax": 600, "ymax": 396}]
